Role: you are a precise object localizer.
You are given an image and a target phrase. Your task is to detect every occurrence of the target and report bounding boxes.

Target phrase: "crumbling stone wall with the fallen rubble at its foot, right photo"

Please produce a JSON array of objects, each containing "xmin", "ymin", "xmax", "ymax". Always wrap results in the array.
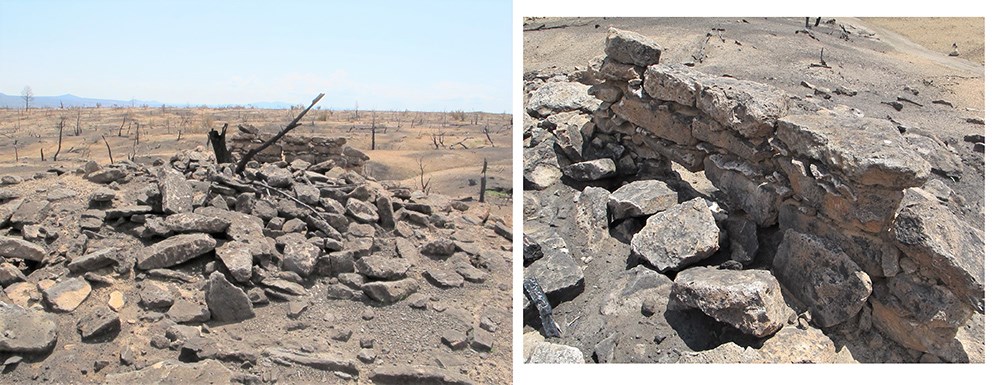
[{"xmin": 523, "ymin": 28, "xmax": 985, "ymax": 362}]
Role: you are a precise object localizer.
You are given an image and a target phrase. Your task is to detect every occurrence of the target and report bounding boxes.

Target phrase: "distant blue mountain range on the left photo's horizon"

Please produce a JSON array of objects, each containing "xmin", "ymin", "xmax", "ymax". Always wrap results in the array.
[{"xmin": 0, "ymin": 92, "xmax": 292, "ymax": 109}]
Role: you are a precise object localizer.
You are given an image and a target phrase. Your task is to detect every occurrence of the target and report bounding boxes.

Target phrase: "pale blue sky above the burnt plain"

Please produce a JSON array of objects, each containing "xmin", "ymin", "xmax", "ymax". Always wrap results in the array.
[{"xmin": 0, "ymin": 0, "xmax": 514, "ymax": 112}]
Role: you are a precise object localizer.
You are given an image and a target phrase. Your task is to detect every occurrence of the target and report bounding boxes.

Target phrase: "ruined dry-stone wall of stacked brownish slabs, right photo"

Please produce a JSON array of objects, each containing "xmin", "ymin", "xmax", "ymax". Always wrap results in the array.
[{"xmin": 525, "ymin": 29, "xmax": 985, "ymax": 357}]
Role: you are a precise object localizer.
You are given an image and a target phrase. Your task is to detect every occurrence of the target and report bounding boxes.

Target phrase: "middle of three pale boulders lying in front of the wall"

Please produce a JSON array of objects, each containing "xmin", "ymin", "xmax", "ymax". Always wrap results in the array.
[{"xmin": 631, "ymin": 198, "xmax": 721, "ymax": 271}]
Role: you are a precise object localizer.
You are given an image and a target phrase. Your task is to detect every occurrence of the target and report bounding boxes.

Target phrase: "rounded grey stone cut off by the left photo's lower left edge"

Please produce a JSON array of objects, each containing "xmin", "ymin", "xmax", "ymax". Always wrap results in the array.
[{"xmin": 0, "ymin": 301, "xmax": 58, "ymax": 354}]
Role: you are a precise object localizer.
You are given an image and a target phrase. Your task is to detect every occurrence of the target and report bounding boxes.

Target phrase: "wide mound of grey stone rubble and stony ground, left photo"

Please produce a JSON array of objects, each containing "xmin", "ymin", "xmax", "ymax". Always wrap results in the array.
[{"xmin": 0, "ymin": 141, "xmax": 510, "ymax": 384}]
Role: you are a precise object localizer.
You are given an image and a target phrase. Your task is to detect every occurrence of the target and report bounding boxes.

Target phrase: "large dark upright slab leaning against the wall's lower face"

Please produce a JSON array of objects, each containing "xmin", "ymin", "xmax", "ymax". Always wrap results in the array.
[{"xmin": 773, "ymin": 230, "xmax": 872, "ymax": 327}]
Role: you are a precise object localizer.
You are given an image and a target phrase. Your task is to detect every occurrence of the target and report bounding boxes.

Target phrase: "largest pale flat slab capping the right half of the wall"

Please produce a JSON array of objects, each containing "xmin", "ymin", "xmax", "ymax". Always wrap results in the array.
[{"xmin": 776, "ymin": 110, "xmax": 931, "ymax": 190}]
